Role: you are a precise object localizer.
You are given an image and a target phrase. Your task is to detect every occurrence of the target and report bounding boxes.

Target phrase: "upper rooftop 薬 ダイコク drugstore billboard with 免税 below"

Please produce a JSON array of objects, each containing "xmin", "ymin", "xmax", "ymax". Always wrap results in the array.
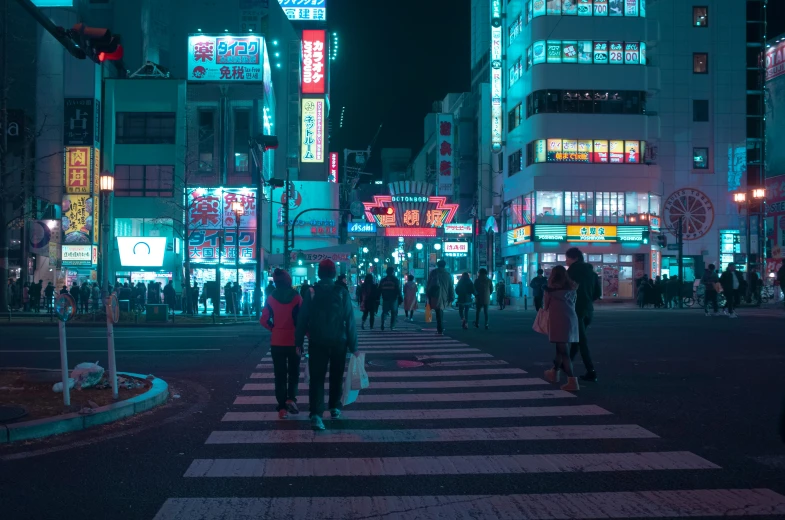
[{"xmin": 188, "ymin": 34, "xmax": 264, "ymax": 82}]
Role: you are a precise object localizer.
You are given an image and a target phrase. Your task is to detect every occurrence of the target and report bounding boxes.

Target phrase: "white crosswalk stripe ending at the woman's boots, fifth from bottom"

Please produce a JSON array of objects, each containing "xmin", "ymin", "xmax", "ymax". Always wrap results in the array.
[{"xmin": 234, "ymin": 390, "xmax": 576, "ymax": 405}]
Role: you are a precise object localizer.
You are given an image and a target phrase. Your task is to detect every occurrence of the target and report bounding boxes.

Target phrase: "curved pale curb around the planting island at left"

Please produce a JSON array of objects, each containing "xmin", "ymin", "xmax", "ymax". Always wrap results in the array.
[{"xmin": 0, "ymin": 372, "xmax": 169, "ymax": 444}]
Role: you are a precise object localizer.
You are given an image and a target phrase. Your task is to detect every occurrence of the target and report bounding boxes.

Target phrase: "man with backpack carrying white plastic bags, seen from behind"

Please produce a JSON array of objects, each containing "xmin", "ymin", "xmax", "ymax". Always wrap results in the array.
[{"xmin": 295, "ymin": 260, "xmax": 357, "ymax": 430}]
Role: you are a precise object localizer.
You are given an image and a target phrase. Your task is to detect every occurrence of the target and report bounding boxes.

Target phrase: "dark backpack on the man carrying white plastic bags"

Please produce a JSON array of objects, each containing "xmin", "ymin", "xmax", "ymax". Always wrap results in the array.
[{"xmin": 308, "ymin": 284, "xmax": 349, "ymax": 347}]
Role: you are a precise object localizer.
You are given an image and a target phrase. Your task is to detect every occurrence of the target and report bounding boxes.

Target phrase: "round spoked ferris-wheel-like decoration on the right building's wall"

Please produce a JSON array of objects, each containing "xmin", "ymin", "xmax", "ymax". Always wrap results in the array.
[{"xmin": 663, "ymin": 188, "xmax": 714, "ymax": 240}]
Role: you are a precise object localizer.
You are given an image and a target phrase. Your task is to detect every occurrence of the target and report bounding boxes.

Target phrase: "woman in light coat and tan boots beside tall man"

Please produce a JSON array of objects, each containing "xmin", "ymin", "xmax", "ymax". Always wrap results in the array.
[{"xmin": 543, "ymin": 265, "xmax": 580, "ymax": 391}]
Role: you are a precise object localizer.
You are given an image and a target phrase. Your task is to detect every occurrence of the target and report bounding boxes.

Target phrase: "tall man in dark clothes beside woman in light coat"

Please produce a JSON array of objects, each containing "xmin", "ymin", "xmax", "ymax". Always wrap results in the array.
[{"xmin": 566, "ymin": 247, "xmax": 602, "ymax": 383}]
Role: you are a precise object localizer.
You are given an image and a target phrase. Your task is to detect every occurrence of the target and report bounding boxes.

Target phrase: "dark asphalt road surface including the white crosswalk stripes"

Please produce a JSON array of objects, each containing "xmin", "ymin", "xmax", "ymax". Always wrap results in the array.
[{"xmin": 0, "ymin": 308, "xmax": 785, "ymax": 520}]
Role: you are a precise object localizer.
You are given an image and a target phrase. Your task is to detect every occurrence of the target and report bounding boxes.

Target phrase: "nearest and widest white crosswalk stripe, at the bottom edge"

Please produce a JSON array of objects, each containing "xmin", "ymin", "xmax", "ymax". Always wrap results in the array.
[{"xmin": 154, "ymin": 489, "xmax": 785, "ymax": 520}]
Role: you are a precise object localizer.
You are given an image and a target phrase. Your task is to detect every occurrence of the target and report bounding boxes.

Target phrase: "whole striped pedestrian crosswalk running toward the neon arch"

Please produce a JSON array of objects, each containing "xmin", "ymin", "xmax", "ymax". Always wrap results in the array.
[{"xmin": 155, "ymin": 324, "xmax": 785, "ymax": 520}]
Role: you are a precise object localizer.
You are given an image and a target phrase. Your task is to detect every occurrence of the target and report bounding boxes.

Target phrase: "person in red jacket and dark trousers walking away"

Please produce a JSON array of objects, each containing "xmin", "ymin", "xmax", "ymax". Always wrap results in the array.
[{"xmin": 259, "ymin": 269, "xmax": 303, "ymax": 419}]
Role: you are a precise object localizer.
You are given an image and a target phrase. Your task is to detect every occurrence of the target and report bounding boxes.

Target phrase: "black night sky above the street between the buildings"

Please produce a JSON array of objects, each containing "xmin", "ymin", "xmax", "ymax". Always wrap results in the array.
[{"xmin": 328, "ymin": 0, "xmax": 785, "ymax": 174}]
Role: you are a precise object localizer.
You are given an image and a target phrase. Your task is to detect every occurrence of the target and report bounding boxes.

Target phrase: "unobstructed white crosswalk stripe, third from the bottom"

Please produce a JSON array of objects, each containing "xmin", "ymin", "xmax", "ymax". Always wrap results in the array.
[{"xmin": 205, "ymin": 424, "xmax": 659, "ymax": 444}]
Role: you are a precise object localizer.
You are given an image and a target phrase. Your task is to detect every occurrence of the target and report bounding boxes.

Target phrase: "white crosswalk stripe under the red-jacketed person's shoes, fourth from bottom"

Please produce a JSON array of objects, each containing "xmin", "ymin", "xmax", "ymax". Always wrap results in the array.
[{"xmin": 221, "ymin": 404, "xmax": 613, "ymax": 422}]
